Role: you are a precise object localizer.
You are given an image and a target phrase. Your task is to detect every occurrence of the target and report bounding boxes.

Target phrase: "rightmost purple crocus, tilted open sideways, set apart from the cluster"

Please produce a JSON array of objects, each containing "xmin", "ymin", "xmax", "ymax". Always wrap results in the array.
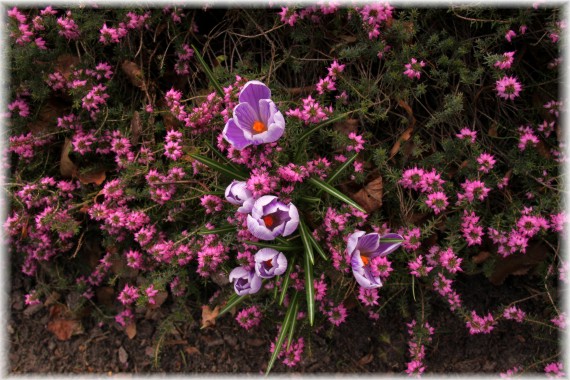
[{"xmin": 346, "ymin": 231, "xmax": 404, "ymax": 289}]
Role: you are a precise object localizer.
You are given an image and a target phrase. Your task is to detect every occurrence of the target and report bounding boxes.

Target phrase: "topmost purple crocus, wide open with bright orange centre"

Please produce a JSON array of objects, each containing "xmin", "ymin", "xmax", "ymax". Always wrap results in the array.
[{"xmin": 223, "ymin": 80, "xmax": 285, "ymax": 150}]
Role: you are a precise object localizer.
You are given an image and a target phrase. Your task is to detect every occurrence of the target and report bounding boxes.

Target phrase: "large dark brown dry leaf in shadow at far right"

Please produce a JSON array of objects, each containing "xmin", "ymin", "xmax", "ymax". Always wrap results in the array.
[{"xmin": 489, "ymin": 242, "xmax": 550, "ymax": 285}]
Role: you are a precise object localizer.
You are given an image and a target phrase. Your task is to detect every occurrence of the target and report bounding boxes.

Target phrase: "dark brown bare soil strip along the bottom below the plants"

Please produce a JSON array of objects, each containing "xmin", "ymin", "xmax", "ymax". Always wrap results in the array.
[{"xmin": 9, "ymin": 266, "xmax": 560, "ymax": 374}]
